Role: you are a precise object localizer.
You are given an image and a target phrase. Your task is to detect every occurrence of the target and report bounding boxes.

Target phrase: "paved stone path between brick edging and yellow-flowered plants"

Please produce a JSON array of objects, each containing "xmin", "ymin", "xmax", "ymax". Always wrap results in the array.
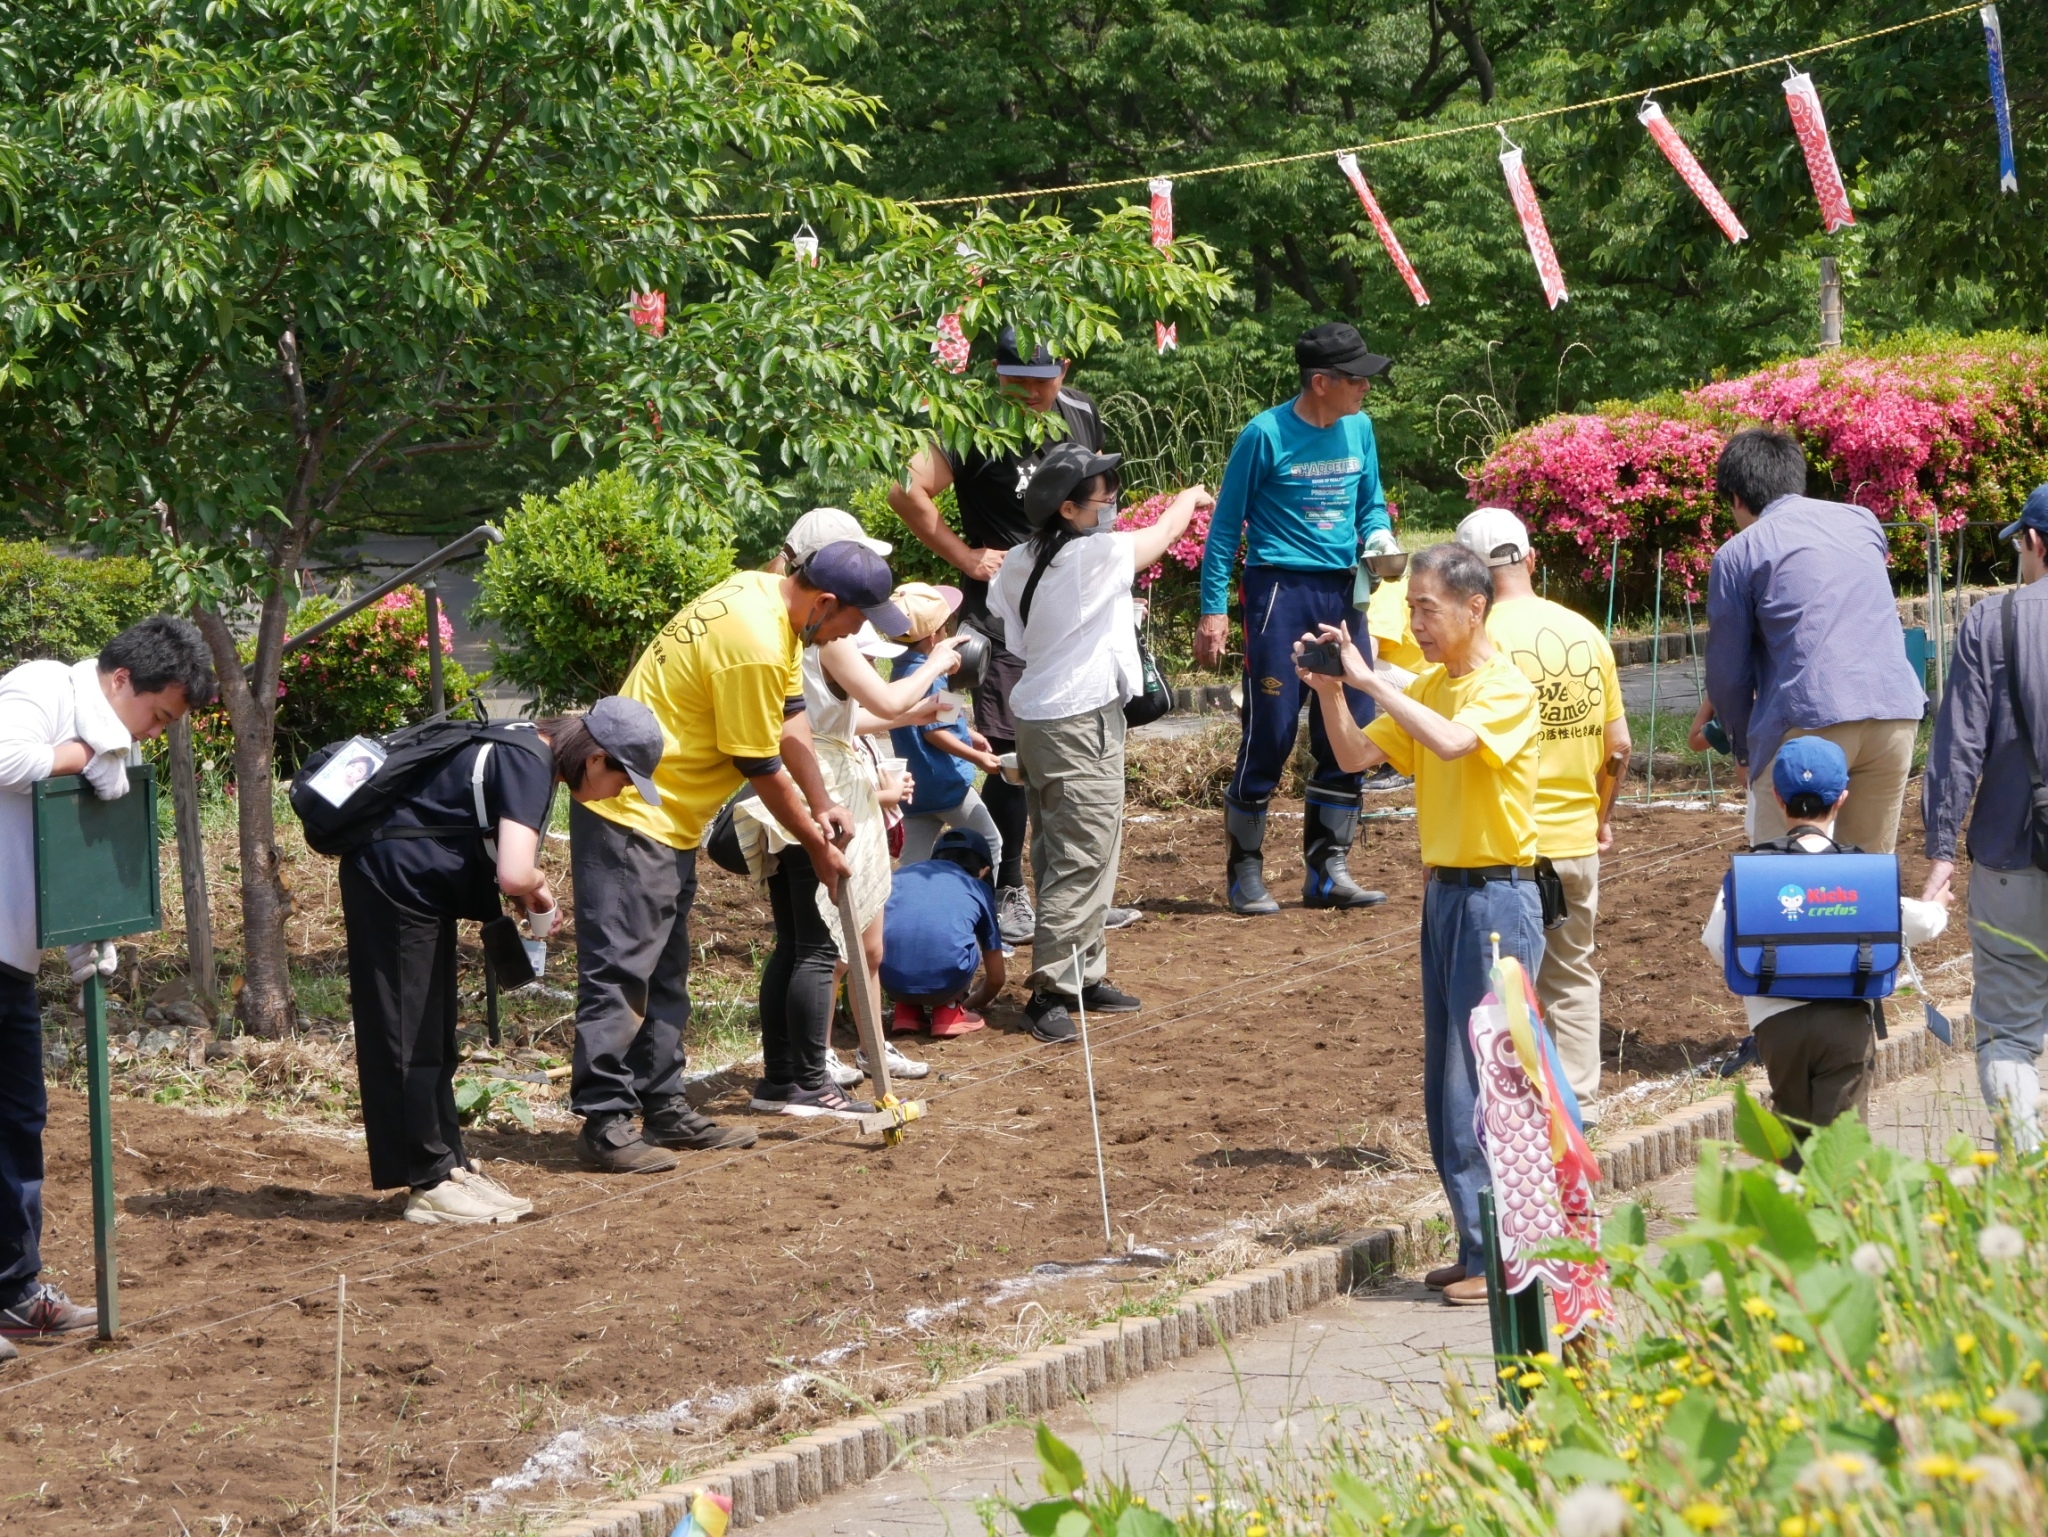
[{"xmin": 762, "ymin": 1053, "xmax": 1991, "ymax": 1537}]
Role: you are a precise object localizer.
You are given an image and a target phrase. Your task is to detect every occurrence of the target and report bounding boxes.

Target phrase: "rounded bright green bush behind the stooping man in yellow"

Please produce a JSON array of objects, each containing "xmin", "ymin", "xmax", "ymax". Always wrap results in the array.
[{"xmin": 471, "ymin": 469, "xmax": 733, "ymax": 713}]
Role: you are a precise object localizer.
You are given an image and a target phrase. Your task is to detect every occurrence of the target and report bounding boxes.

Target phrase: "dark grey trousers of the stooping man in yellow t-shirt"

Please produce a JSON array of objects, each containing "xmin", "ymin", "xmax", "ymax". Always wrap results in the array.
[{"xmin": 569, "ymin": 801, "xmax": 696, "ymax": 1117}]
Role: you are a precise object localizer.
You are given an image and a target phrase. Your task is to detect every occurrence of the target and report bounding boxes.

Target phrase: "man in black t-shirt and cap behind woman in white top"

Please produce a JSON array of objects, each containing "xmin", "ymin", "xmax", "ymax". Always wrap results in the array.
[{"xmin": 889, "ymin": 326, "xmax": 1105, "ymax": 945}]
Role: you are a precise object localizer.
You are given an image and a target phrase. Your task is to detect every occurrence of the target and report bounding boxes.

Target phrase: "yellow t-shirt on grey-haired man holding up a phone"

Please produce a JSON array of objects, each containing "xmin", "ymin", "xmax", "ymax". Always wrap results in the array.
[{"xmin": 1366, "ymin": 652, "xmax": 1542, "ymax": 869}]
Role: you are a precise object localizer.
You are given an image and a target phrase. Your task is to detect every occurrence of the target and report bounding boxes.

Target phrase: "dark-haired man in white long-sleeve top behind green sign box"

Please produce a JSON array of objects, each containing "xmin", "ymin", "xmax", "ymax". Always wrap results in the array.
[{"xmin": 0, "ymin": 617, "xmax": 215, "ymax": 1361}]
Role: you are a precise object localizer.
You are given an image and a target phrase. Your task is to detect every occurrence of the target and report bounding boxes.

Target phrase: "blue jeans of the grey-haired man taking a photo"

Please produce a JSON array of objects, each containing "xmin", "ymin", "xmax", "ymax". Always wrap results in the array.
[{"xmin": 1421, "ymin": 875, "xmax": 1542, "ymax": 1275}]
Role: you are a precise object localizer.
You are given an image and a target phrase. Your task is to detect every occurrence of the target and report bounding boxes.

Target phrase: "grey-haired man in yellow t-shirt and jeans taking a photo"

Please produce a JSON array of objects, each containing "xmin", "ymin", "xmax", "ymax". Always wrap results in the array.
[{"xmin": 1300, "ymin": 545, "xmax": 1542, "ymax": 1305}]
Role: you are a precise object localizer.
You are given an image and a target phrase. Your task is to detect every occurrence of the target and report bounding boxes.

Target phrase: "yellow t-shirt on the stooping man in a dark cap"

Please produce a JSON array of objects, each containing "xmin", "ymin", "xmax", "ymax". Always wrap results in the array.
[{"xmin": 590, "ymin": 572, "xmax": 803, "ymax": 848}]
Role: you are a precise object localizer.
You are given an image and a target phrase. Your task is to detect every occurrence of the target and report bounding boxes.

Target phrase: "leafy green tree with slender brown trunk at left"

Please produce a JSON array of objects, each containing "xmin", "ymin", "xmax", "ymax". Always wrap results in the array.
[{"xmin": 0, "ymin": 0, "xmax": 1225, "ymax": 1031}]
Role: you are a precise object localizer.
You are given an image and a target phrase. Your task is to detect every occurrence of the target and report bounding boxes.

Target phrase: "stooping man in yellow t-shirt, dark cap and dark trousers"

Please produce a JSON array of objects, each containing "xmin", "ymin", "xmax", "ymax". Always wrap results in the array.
[{"xmin": 569, "ymin": 541, "xmax": 909, "ymax": 1174}]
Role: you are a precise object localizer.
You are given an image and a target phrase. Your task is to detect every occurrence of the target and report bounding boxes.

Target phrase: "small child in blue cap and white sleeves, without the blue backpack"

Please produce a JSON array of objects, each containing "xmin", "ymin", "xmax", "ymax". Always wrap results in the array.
[{"xmin": 1700, "ymin": 736, "xmax": 1952, "ymax": 1168}]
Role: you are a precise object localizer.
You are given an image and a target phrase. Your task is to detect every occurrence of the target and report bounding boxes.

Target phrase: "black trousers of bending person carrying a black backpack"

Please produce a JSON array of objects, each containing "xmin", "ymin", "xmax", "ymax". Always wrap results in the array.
[{"xmin": 342, "ymin": 859, "xmax": 467, "ymax": 1191}]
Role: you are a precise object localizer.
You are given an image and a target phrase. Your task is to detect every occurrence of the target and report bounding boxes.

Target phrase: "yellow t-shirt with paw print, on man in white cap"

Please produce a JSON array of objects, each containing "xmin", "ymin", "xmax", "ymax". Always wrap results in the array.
[{"xmin": 1487, "ymin": 596, "xmax": 1622, "ymax": 859}]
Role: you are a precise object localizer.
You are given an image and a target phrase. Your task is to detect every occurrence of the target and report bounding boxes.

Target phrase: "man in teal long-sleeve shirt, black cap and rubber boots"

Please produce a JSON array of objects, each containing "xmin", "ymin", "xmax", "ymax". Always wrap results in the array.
[{"xmin": 1194, "ymin": 322, "xmax": 1399, "ymax": 912}]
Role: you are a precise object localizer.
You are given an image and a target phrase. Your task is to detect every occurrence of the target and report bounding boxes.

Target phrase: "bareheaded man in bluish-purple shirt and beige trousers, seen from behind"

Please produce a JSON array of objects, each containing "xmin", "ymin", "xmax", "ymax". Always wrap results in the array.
[{"xmin": 1706, "ymin": 426, "xmax": 1927, "ymax": 855}]
